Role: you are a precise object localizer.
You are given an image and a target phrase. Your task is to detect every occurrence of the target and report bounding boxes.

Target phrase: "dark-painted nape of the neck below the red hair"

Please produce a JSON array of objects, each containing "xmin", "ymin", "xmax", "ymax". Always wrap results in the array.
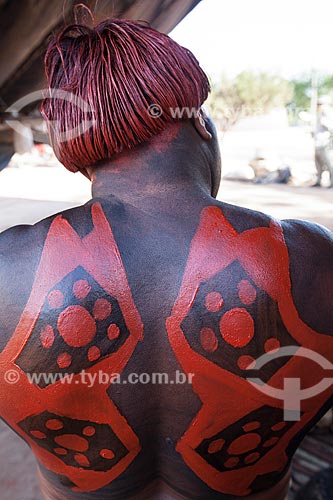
[{"xmin": 88, "ymin": 124, "xmax": 212, "ymax": 212}]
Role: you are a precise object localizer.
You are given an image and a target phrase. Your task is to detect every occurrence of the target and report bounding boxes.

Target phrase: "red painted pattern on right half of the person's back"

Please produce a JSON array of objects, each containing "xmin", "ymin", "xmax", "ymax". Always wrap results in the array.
[{"xmin": 166, "ymin": 207, "xmax": 333, "ymax": 496}]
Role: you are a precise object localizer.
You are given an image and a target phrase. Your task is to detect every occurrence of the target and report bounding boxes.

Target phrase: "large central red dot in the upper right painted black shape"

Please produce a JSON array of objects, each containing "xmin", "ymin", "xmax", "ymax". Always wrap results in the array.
[{"xmin": 220, "ymin": 308, "xmax": 254, "ymax": 347}]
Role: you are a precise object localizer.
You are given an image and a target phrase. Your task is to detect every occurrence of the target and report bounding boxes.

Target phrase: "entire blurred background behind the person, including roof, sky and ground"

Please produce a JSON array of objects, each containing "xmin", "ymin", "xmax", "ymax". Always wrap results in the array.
[{"xmin": 0, "ymin": 0, "xmax": 333, "ymax": 500}]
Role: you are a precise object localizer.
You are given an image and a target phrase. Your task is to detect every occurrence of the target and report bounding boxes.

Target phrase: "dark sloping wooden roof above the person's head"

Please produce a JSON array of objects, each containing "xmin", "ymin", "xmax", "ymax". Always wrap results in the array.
[{"xmin": 0, "ymin": 0, "xmax": 200, "ymax": 109}]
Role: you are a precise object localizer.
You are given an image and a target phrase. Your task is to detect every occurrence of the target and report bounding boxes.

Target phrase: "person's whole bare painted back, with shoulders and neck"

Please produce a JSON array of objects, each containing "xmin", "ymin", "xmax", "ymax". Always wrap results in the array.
[{"xmin": 0, "ymin": 119, "xmax": 333, "ymax": 500}]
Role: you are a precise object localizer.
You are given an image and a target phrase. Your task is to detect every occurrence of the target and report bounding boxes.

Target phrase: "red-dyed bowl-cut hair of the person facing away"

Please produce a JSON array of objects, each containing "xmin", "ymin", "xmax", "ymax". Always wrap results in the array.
[{"xmin": 41, "ymin": 19, "xmax": 210, "ymax": 172}]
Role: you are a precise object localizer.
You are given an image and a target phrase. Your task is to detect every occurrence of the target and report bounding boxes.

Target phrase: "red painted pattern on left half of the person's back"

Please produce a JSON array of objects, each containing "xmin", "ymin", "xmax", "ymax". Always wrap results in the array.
[{"xmin": 0, "ymin": 203, "xmax": 143, "ymax": 491}]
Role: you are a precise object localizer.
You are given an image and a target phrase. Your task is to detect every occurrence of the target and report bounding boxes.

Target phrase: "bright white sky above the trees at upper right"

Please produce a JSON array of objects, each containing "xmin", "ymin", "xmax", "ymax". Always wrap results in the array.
[{"xmin": 170, "ymin": 0, "xmax": 333, "ymax": 80}]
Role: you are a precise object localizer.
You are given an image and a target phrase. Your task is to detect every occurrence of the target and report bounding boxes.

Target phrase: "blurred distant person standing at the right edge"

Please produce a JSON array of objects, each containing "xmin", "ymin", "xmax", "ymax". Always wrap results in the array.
[{"xmin": 314, "ymin": 100, "xmax": 333, "ymax": 187}]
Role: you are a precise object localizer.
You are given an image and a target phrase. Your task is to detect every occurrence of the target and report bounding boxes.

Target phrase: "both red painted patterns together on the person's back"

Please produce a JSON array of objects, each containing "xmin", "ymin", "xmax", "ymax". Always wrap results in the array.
[{"xmin": 0, "ymin": 203, "xmax": 333, "ymax": 496}]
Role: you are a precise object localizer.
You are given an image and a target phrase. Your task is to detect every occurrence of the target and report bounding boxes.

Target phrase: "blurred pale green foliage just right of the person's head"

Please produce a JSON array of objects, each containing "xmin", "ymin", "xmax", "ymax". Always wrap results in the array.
[{"xmin": 207, "ymin": 71, "xmax": 293, "ymax": 130}]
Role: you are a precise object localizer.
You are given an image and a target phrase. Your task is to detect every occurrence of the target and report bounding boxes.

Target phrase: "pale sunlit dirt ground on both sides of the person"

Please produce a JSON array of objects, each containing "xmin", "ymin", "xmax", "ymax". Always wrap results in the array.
[{"xmin": 0, "ymin": 167, "xmax": 333, "ymax": 500}]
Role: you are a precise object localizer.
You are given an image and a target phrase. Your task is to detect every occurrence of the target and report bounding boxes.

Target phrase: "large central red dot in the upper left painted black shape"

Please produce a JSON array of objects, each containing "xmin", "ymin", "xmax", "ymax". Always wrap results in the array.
[{"xmin": 58, "ymin": 306, "xmax": 96, "ymax": 347}]
